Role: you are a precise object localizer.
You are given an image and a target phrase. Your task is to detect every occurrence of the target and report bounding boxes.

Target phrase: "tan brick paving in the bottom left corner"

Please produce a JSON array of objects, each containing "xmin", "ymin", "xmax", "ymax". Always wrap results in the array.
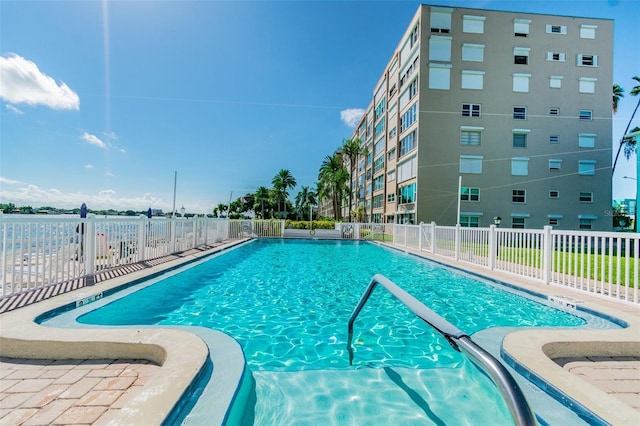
[{"xmin": 0, "ymin": 357, "xmax": 161, "ymax": 426}]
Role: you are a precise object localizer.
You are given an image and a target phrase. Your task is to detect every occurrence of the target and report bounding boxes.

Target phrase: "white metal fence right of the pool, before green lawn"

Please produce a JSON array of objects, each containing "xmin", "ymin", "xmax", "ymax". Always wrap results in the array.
[{"xmin": 393, "ymin": 223, "xmax": 640, "ymax": 304}]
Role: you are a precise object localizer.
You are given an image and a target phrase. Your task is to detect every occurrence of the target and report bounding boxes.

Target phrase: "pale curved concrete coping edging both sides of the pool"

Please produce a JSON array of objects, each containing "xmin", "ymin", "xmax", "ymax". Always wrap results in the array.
[{"xmin": 0, "ymin": 239, "xmax": 640, "ymax": 425}]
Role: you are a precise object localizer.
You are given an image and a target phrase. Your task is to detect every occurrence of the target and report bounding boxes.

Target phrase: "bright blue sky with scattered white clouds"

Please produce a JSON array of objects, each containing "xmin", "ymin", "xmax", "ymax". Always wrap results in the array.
[{"xmin": 0, "ymin": 0, "xmax": 640, "ymax": 213}]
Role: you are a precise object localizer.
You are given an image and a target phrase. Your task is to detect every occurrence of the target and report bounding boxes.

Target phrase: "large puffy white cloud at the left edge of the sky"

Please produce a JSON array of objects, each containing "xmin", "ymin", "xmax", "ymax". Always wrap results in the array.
[{"xmin": 0, "ymin": 54, "xmax": 80, "ymax": 110}]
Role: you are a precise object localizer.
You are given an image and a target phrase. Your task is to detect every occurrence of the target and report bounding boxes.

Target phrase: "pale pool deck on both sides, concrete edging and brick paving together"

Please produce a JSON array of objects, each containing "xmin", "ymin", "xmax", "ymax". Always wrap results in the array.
[{"xmin": 0, "ymin": 241, "xmax": 640, "ymax": 425}]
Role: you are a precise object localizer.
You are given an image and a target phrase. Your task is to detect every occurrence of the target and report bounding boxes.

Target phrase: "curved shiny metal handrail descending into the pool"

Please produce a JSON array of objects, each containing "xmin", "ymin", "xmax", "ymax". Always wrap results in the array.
[{"xmin": 347, "ymin": 274, "xmax": 537, "ymax": 426}]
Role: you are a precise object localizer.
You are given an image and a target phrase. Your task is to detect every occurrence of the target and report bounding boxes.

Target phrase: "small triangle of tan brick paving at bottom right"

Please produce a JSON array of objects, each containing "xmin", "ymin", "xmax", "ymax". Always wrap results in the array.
[{"xmin": 554, "ymin": 356, "xmax": 640, "ymax": 413}]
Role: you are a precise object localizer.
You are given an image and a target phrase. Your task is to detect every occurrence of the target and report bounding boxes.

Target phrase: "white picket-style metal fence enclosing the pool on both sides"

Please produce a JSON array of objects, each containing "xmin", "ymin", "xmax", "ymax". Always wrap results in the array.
[{"xmin": 0, "ymin": 214, "xmax": 640, "ymax": 304}]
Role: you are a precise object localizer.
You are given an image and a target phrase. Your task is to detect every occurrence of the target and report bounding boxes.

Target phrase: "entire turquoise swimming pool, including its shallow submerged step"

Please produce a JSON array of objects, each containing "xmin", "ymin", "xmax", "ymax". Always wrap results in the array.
[{"xmin": 40, "ymin": 240, "xmax": 620, "ymax": 424}]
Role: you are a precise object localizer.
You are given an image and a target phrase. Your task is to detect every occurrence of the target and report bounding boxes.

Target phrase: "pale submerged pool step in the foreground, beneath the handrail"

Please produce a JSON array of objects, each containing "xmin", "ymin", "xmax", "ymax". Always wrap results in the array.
[{"xmin": 248, "ymin": 367, "xmax": 511, "ymax": 425}]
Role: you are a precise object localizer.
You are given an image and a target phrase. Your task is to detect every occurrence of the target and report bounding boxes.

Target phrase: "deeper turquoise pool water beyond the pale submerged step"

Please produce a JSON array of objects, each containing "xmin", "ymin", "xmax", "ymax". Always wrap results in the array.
[{"xmin": 78, "ymin": 240, "xmax": 585, "ymax": 371}]
